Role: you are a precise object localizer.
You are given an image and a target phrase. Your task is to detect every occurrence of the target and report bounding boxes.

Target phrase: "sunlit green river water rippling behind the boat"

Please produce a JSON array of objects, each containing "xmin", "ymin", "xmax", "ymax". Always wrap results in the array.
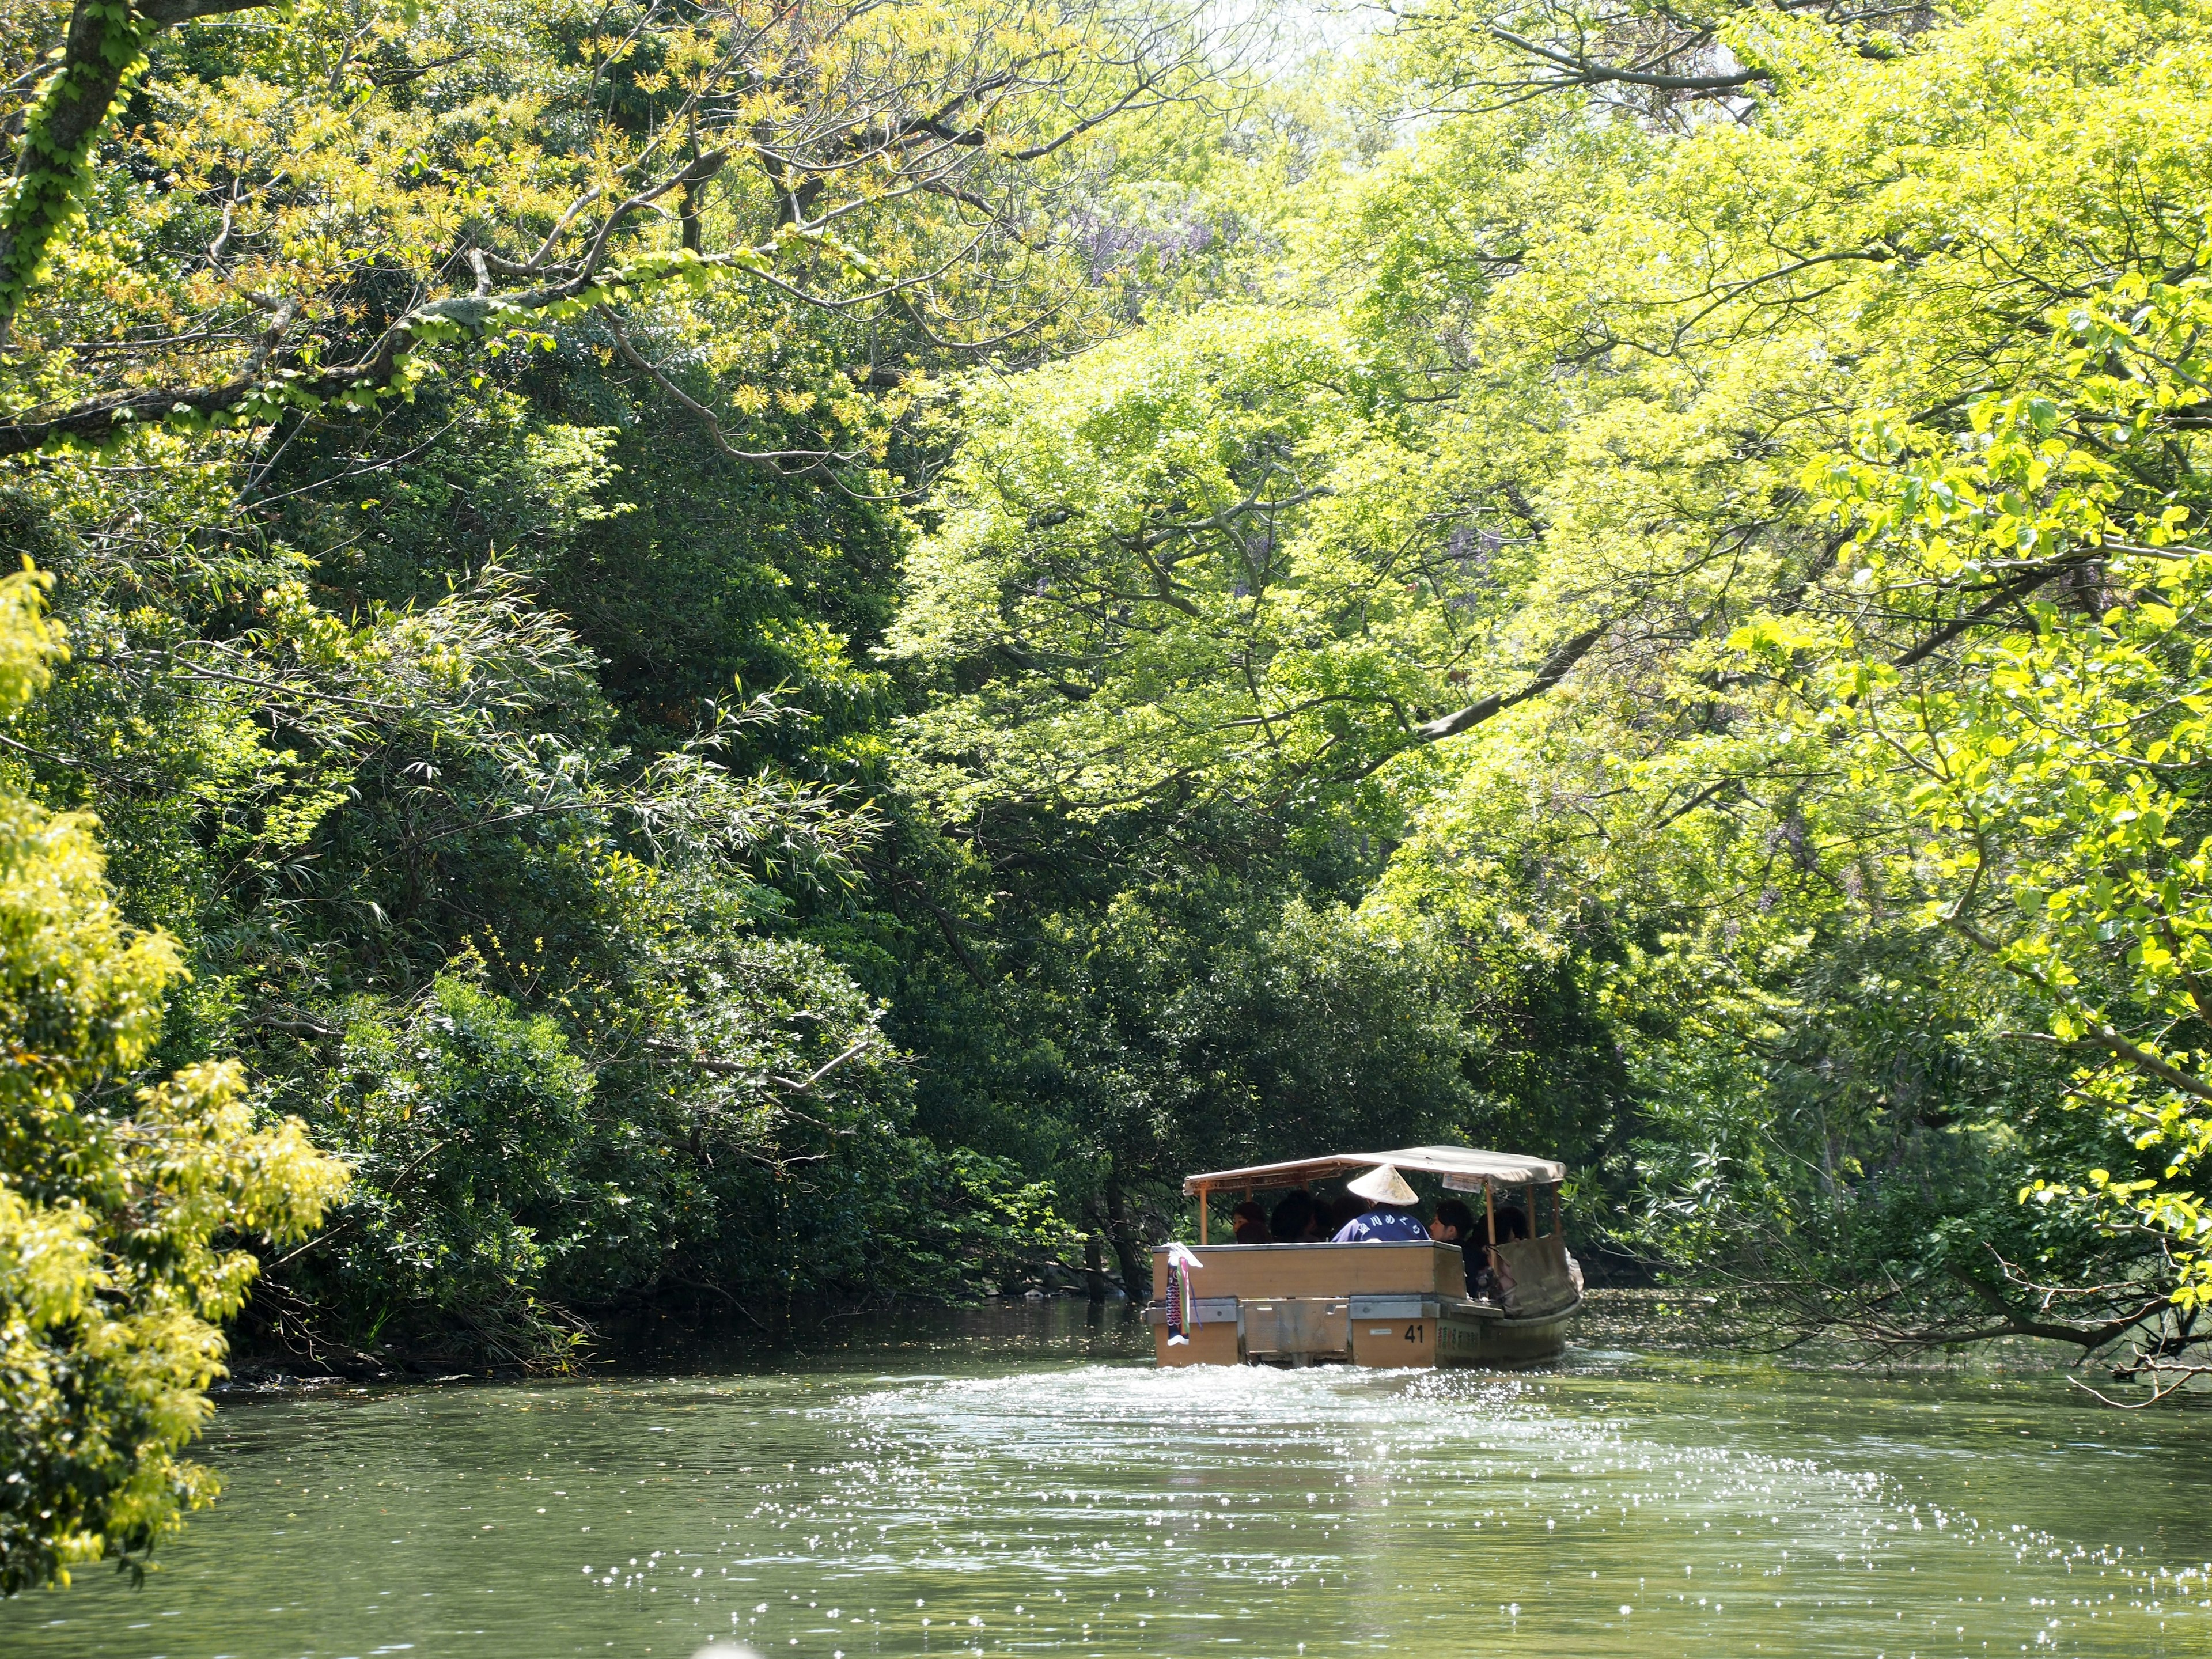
[{"xmin": 0, "ymin": 1303, "xmax": 2212, "ymax": 1659}]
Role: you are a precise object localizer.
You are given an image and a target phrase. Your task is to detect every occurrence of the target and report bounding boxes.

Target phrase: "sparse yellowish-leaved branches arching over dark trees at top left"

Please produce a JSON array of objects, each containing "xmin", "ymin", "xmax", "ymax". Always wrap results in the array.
[{"xmin": 0, "ymin": 0, "xmax": 1212, "ymax": 457}]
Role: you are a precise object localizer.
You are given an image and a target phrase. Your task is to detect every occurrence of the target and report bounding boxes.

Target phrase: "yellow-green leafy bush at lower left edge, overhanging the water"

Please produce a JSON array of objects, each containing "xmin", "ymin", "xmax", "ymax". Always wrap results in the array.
[{"xmin": 0, "ymin": 573, "xmax": 345, "ymax": 1595}]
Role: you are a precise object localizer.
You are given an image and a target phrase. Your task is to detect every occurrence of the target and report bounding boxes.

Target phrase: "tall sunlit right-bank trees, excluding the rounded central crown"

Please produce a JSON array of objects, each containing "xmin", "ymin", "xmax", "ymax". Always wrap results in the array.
[{"xmin": 1291, "ymin": 5, "xmax": 2205, "ymax": 1347}]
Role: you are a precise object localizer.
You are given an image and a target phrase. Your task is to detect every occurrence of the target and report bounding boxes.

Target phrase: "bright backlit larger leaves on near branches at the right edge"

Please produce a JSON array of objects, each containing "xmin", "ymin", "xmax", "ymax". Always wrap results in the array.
[{"xmin": 1814, "ymin": 279, "xmax": 2212, "ymax": 1309}]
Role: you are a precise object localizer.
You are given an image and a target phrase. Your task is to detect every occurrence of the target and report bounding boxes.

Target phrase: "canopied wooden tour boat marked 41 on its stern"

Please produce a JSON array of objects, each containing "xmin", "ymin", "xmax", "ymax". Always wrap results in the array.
[{"xmin": 1146, "ymin": 1146, "xmax": 1582, "ymax": 1367}]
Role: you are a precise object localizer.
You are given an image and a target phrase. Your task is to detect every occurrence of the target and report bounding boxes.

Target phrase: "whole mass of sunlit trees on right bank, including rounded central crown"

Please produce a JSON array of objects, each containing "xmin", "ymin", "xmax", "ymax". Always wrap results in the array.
[{"xmin": 889, "ymin": 0, "xmax": 2212, "ymax": 1371}]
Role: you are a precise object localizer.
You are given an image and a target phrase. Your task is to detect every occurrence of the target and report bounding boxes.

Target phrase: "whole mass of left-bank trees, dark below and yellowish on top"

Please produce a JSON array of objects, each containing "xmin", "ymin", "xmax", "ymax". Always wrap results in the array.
[{"xmin": 0, "ymin": 0, "xmax": 1247, "ymax": 1369}]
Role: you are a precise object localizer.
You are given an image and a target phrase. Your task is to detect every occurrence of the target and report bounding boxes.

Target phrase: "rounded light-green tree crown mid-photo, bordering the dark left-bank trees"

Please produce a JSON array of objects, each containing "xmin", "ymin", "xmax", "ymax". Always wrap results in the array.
[{"xmin": 892, "ymin": 308, "xmax": 1475, "ymax": 812}]
